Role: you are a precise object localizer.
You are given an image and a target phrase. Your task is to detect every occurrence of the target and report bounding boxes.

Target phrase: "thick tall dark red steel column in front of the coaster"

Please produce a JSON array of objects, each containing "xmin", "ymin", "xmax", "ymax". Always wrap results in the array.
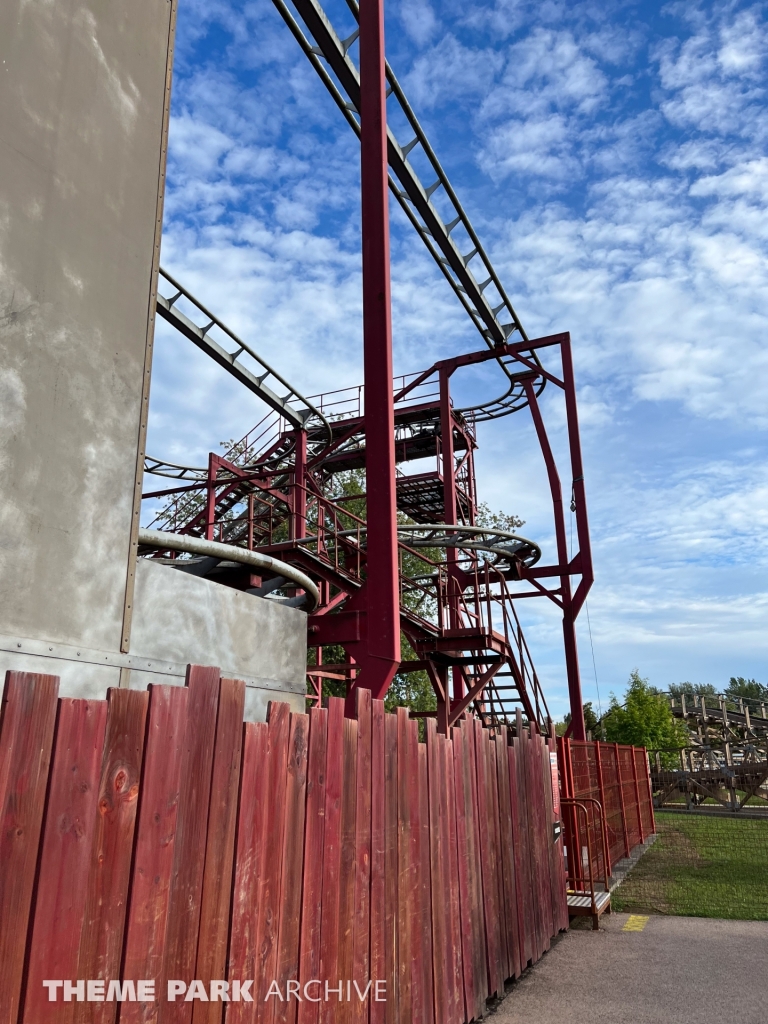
[{"xmin": 347, "ymin": 0, "xmax": 400, "ymax": 717}]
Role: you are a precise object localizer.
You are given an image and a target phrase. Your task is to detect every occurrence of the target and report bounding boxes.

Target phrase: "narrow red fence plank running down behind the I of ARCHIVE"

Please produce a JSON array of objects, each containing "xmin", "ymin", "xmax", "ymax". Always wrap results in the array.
[{"xmin": 334, "ymin": 718, "xmax": 357, "ymax": 1024}]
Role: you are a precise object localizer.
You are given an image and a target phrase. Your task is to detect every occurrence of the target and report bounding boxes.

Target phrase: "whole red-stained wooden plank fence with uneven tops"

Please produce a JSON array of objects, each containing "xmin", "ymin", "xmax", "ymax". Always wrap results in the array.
[{"xmin": 0, "ymin": 667, "xmax": 568, "ymax": 1024}]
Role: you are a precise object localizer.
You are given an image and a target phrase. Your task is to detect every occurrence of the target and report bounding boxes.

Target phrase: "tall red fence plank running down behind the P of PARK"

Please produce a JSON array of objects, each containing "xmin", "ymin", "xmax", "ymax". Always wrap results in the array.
[{"xmin": 158, "ymin": 665, "xmax": 220, "ymax": 1024}]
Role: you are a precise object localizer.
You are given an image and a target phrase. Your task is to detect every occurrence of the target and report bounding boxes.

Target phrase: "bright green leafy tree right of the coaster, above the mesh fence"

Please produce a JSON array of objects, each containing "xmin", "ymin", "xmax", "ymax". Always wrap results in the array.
[{"xmin": 603, "ymin": 669, "xmax": 688, "ymax": 768}]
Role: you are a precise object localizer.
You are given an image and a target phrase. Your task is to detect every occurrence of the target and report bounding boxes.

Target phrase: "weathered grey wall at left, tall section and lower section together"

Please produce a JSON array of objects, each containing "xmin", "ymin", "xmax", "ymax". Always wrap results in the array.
[{"xmin": 0, "ymin": 0, "xmax": 306, "ymax": 717}]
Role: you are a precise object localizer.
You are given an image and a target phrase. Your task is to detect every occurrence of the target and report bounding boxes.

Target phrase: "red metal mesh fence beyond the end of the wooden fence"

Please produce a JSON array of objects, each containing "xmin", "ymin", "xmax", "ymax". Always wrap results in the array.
[{"xmin": 558, "ymin": 738, "xmax": 655, "ymax": 878}]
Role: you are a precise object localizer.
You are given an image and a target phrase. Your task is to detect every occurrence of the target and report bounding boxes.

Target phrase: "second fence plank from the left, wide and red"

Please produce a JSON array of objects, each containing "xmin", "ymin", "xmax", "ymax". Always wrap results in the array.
[{"xmin": 19, "ymin": 697, "xmax": 106, "ymax": 1024}]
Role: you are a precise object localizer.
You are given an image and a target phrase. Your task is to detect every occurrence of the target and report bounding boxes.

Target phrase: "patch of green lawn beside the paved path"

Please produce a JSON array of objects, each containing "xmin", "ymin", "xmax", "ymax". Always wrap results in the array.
[{"xmin": 611, "ymin": 811, "xmax": 768, "ymax": 921}]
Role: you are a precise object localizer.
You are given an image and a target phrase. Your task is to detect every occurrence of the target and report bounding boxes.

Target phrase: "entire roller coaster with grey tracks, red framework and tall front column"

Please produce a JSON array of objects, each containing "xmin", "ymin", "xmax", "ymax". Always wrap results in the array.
[{"xmin": 140, "ymin": 0, "xmax": 592, "ymax": 739}]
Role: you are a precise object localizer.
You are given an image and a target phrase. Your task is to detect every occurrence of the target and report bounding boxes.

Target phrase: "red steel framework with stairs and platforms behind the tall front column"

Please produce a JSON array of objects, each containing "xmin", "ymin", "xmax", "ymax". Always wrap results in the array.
[{"xmin": 145, "ymin": 334, "xmax": 592, "ymax": 731}]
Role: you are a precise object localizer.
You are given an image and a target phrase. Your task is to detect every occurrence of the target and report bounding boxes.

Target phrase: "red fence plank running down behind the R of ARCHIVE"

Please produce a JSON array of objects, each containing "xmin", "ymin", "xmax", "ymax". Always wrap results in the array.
[{"xmin": 274, "ymin": 714, "xmax": 309, "ymax": 1024}]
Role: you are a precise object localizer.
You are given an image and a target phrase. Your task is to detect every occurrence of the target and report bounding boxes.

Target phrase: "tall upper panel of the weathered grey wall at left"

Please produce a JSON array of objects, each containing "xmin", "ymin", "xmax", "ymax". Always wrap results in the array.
[{"xmin": 0, "ymin": 0, "xmax": 171, "ymax": 650}]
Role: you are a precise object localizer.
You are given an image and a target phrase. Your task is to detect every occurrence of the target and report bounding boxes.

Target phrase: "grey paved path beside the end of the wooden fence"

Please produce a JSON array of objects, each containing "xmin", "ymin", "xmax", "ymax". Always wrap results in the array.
[{"xmin": 490, "ymin": 913, "xmax": 768, "ymax": 1024}]
